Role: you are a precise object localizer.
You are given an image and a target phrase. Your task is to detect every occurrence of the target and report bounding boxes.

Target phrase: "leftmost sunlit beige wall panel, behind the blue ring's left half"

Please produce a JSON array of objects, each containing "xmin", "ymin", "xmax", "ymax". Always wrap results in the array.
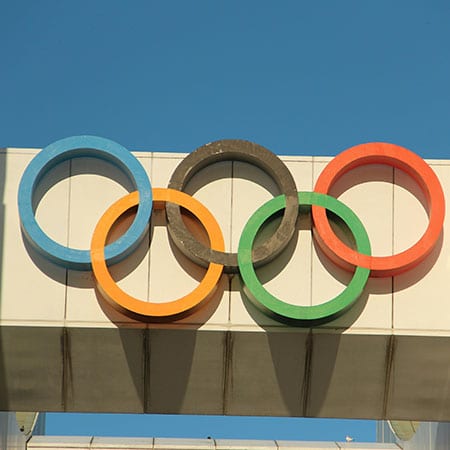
[{"xmin": 0, "ymin": 150, "xmax": 68, "ymax": 325}]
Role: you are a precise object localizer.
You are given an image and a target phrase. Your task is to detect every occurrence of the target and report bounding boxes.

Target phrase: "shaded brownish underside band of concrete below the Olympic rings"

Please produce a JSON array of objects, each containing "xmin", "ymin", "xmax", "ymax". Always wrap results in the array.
[{"xmin": 0, "ymin": 326, "xmax": 450, "ymax": 421}]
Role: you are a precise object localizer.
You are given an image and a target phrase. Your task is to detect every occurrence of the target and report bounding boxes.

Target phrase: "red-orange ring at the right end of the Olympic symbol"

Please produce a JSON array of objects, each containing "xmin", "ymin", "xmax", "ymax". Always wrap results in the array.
[{"xmin": 312, "ymin": 142, "xmax": 445, "ymax": 277}]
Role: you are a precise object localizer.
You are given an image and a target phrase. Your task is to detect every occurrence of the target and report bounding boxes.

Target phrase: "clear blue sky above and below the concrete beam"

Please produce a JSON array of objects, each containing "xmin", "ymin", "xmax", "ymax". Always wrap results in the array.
[{"xmin": 0, "ymin": 0, "xmax": 450, "ymax": 440}]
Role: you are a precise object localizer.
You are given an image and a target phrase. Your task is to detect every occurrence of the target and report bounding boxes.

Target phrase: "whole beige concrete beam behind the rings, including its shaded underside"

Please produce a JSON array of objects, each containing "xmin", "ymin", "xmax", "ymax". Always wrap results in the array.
[{"xmin": 0, "ymin": 149, "xmax": 450, "ymax": 420}]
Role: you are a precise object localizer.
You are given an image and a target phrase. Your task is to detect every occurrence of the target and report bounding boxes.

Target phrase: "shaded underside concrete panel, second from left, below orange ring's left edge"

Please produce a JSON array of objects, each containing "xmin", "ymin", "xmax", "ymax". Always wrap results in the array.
[{"xmin": 64, "ymin": 328, "xmax": 146, "ymax": 413}]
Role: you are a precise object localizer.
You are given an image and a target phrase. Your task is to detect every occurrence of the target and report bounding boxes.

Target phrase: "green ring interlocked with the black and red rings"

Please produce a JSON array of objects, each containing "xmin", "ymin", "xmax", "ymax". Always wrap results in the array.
[{"xmin": 238, "ymin": 192, "xmax": 371, "ymax": 326}]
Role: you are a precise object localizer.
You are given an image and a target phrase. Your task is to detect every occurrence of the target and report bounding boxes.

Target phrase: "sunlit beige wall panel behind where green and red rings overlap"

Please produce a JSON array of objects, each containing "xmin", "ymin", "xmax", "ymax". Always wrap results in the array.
[{"xmin": 311, "ymin": 157, "xmax": 393, "ymax": 329}]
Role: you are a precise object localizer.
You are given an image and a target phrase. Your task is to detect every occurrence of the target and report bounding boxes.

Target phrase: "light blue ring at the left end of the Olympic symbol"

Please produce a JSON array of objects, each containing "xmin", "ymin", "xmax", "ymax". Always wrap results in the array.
[{"xmin": 18, "ymin": 136, "xmax": 152, "ymax": 270}]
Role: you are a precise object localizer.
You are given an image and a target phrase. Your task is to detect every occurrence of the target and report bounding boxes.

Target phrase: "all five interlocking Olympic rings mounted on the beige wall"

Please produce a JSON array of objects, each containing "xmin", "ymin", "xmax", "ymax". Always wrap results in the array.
[{"xmin": 18, "ymin": 136, "xmax": 445, "ymax": 325}]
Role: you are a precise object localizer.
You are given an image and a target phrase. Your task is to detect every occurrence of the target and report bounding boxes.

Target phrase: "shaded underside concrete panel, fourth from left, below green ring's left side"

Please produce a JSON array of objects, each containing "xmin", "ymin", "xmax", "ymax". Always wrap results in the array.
[{"xmin": 226, "ymin": 330, "xmax": 308, "ymax": 416}]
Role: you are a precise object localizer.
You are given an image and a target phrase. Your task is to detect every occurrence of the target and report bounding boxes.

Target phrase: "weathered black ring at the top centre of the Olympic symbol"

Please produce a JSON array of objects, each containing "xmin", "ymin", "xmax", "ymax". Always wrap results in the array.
[{"xmin": 166, "ymin": 139, "xmax": 298, "ymax": 273}]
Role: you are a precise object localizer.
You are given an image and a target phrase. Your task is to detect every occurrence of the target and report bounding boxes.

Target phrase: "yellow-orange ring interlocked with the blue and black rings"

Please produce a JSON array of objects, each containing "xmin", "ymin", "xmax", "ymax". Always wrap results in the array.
[{"xmin": 91, "ymin": 189, "xmax": 225, "ymax": 321}]
